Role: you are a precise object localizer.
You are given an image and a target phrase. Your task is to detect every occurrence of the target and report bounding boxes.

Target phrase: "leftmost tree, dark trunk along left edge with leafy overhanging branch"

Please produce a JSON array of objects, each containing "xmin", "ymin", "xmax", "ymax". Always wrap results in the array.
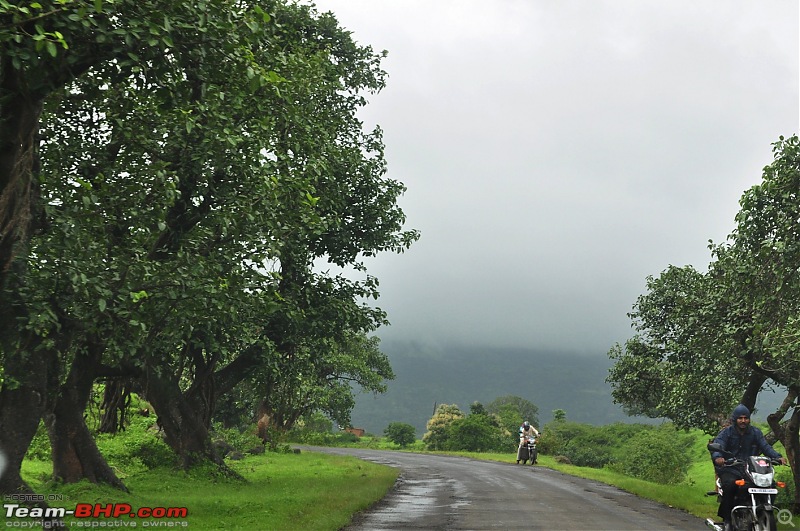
[{"xmin": 0, "ymin": 0, "xmax": 225, "ymax": 492}]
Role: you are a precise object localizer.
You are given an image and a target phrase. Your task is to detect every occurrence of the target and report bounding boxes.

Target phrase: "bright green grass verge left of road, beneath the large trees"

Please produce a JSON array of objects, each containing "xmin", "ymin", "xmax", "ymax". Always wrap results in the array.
[{"xmin": 23, "ymin": 452, "xmax": 399, "ymax": 530}]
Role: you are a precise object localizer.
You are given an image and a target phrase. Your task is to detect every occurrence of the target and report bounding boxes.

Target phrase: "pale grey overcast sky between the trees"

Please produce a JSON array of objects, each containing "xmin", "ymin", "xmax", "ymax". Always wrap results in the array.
[{"xmin": 308, "ymin": 0, "xmax": 800, "ymax": 355}]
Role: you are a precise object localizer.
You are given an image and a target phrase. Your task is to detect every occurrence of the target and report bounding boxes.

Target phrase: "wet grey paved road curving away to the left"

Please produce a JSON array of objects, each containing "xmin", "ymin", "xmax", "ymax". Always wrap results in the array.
[{"xmin": 305, "ymin": 447, "xmax": 708, "ymax": 531}]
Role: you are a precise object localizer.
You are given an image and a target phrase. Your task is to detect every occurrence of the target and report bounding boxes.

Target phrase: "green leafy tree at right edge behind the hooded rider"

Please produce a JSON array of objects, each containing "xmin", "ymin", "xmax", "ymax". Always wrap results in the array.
[{"xmin": 609, "ymin": 135, "xmax": 800, "ymax": 510}]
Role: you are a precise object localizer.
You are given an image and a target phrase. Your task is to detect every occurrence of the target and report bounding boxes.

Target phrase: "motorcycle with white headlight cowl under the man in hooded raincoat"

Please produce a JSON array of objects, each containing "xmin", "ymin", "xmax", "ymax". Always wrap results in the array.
[{"xmin": 706, "ymin": 443, "xmax": 785, "ymax": 531}]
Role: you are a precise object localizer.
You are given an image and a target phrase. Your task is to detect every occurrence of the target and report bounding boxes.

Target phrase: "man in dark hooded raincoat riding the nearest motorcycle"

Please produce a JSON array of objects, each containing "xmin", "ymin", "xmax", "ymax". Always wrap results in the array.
[{"xmin": 711, "ymin": 404, "xmax": 786, "ymax": 530}]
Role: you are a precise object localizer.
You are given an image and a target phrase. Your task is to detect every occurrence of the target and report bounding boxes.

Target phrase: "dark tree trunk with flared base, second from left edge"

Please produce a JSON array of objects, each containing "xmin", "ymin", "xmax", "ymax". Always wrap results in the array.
[{"xmin": 46, "ymin": 342, "xmax": 128, "ymax": 492}]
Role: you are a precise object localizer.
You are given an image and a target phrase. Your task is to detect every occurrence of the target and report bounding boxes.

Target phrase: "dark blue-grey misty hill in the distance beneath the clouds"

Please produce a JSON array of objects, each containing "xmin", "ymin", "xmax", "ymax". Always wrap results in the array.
[{"xmin": 352, "ymin": 342, "xmax": 651, "ymax": 437}]
